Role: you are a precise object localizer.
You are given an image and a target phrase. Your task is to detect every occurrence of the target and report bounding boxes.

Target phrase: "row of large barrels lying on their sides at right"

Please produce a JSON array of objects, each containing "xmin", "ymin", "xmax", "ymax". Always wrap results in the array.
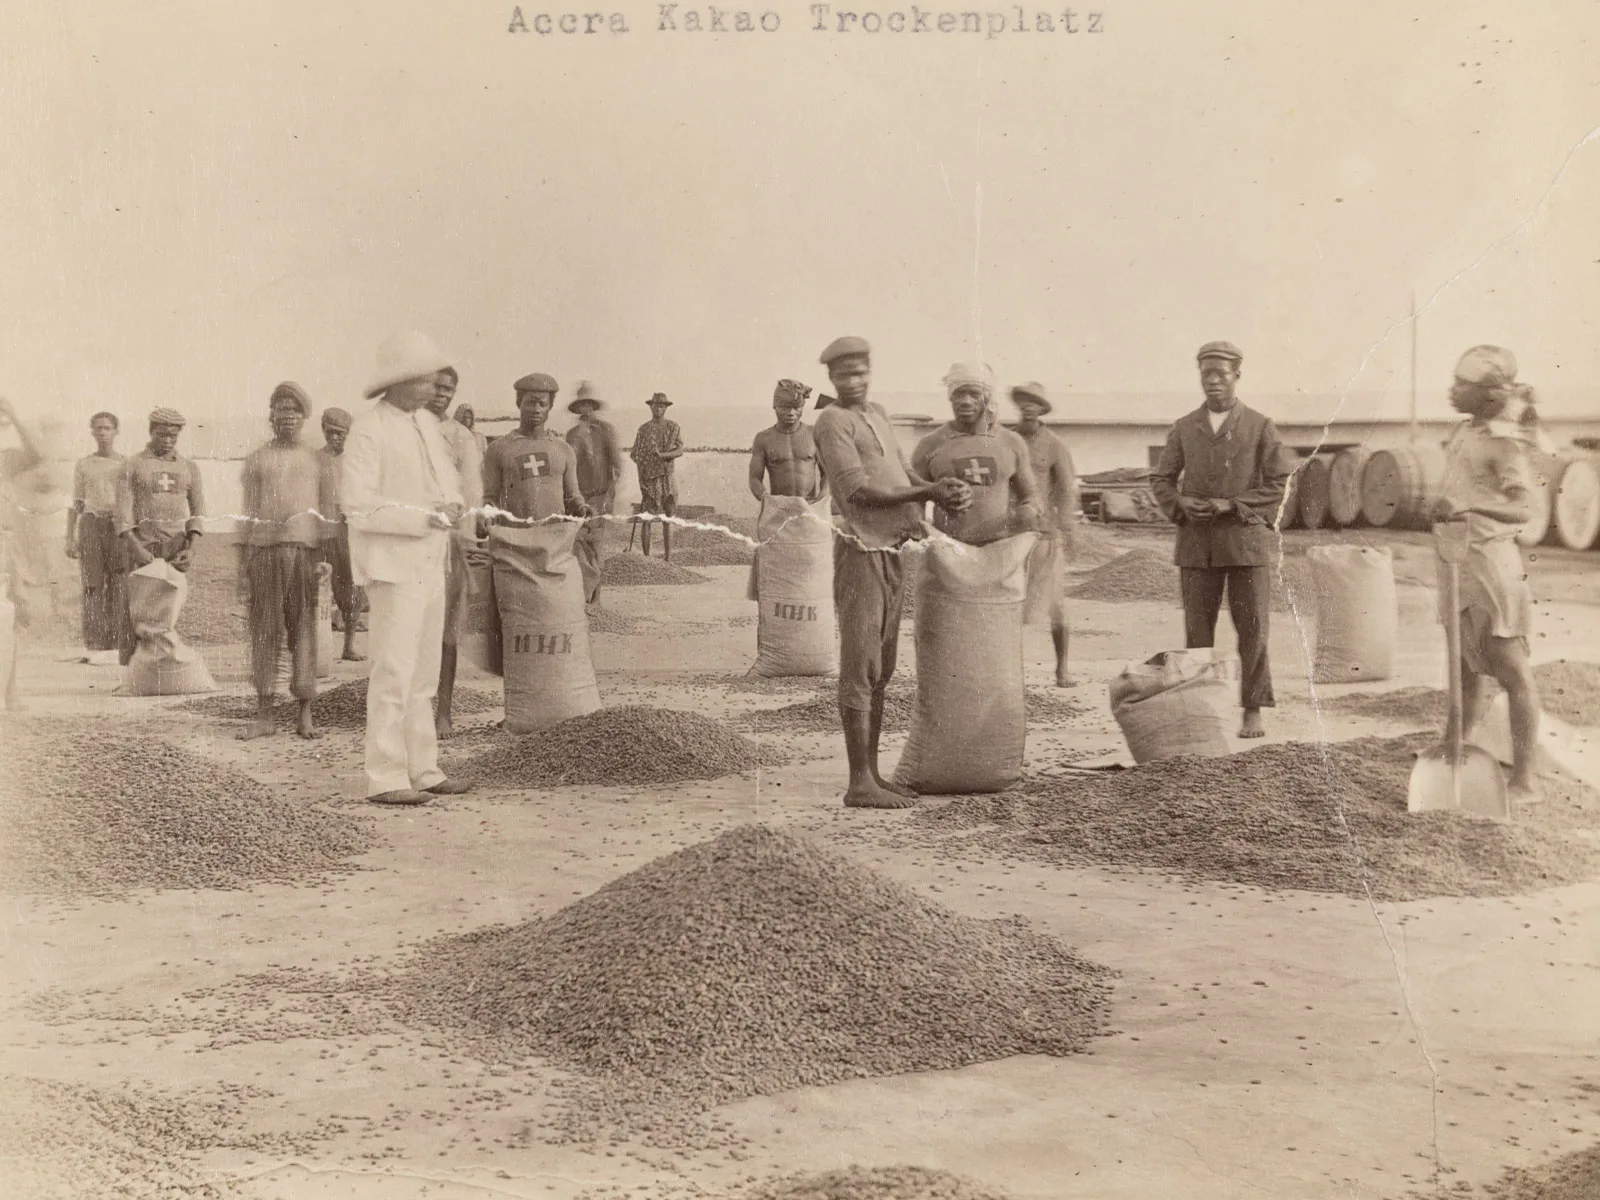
[{"xmin": 1286, "ymin": 442, "xmax": 1600, "ymax": 550}]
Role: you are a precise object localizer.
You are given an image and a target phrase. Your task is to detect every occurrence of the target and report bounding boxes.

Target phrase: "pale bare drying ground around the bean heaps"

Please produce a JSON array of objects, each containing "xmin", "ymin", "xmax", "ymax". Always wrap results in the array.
[{"xmin": 0, "ymin": 541, "xmax": 1600, "ymax": 1200}]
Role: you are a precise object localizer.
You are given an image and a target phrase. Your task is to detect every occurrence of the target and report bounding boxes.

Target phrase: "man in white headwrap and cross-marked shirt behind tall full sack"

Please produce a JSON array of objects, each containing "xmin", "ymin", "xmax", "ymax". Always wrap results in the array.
[{"xmin": 910, "ymin": 363, "xmax": 1038, "ymax": 546}]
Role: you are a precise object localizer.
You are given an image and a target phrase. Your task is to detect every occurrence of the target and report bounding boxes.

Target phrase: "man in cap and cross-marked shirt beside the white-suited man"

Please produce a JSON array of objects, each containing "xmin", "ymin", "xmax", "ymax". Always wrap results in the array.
[{"xmin": 483, "ymin": 371, "xmax": 590, "ymax": 522}]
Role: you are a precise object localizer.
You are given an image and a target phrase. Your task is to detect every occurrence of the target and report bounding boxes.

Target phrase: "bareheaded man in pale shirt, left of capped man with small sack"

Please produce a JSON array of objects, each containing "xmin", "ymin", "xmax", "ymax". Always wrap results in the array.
[{"xmin": 67, "ymin": 413, "xmax": 128, "ymax": 664}]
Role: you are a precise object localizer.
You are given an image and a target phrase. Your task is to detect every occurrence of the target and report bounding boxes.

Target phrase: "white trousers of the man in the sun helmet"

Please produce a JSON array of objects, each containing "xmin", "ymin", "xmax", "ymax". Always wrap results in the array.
[{"xmin": 366, "ymin": 571, "xmax": 445, "ymax": 795}]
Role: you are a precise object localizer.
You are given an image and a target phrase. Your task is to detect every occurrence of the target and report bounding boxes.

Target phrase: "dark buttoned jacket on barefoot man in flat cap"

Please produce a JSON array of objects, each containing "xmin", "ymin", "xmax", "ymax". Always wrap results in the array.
[{"xmin": 1150, "ymin": 405, "xmax": 1294, "ymax": 566}]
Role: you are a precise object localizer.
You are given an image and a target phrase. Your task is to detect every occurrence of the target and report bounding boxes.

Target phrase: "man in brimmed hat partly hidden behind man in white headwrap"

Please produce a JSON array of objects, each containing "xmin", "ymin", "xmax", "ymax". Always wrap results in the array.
[{"xmin": 1011, "ymin": 382, "xmax": 1078, "ymax": 688}]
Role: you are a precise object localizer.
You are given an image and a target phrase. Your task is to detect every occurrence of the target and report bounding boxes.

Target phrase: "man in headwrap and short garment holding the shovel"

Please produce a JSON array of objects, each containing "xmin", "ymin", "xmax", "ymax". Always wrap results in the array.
[{"xmin": 1432, "ymin": 346, "xmax": 1539, "ymax": 803}]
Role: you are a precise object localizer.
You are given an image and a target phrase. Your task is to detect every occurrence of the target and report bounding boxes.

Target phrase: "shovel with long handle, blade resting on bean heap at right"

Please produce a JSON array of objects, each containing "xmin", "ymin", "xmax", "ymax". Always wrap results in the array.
[{"xmin": 1405, "ymin": 522, "xmax": 1510, "ymax": 821}]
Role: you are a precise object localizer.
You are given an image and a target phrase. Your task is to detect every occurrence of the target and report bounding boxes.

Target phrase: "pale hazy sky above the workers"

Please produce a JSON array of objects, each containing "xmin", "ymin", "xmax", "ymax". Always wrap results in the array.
[{"xmin": 0, "ymin": 0, "xmax": 1600, "ymax": 448}]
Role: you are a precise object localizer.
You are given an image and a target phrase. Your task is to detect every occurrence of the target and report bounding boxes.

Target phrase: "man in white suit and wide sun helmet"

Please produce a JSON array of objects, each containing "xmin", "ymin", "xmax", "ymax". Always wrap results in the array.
[{"xmin": 342, "ymin": 333, "xmax": 467, "ymax": 805}]
